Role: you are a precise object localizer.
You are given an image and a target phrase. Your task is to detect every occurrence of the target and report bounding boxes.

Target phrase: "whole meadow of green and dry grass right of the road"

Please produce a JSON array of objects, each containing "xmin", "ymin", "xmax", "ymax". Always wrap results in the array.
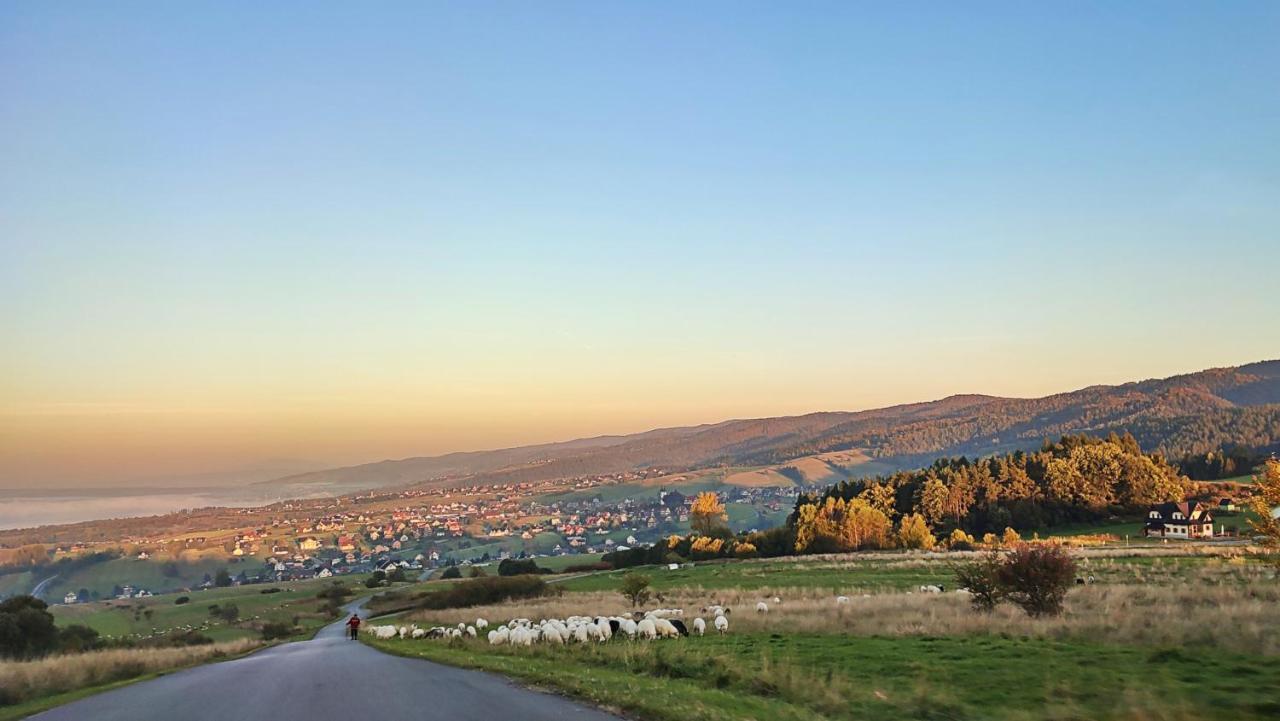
[{"xmin": 370, "ymin": 544, "xmax": 1280, "ymax": 721}]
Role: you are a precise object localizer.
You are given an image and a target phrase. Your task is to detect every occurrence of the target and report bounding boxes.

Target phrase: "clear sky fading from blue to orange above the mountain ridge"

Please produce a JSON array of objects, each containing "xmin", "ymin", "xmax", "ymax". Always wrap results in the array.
[{"xmin": 0, "ymin": 0, "xmax": 1280, "ymax": 488}]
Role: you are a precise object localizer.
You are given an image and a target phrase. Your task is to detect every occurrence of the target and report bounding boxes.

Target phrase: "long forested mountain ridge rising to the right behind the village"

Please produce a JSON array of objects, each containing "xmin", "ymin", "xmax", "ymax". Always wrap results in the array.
[{"xmin": 259, "ymin": 360, "xmax": 1280, "ymax": 493}]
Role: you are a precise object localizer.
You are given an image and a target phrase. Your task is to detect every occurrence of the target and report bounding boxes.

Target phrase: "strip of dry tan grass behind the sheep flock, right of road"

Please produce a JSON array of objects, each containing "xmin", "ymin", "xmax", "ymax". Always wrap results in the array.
[{"xmin": 413, "ymin": 566, "xmax": 1280, "ymax": 656}]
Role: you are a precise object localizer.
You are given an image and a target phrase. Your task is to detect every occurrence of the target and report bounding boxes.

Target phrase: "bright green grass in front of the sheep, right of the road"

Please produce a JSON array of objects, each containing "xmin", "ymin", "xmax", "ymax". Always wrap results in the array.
[{"xmin": 372, "ymin": 634, "xmax": 1280, "ymax": 721}]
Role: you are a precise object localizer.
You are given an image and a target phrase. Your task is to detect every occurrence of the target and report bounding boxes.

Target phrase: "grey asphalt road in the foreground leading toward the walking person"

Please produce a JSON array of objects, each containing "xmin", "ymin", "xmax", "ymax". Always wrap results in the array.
[{"xmin": 32, "ymin": 601, "xmax": 617, "ymax": 721}]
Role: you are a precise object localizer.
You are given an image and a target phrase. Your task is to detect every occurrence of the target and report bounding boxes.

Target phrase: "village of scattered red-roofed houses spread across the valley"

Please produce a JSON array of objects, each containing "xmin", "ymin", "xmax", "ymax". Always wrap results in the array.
[{"xmin": 32, "ymin": 469, "xmax": 803, "ymax": 603}]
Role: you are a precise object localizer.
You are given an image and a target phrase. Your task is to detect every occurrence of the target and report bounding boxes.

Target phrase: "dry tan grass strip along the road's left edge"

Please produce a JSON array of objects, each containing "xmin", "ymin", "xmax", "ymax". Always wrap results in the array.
[{"xmin": 0, "ymin": 639, "xmax": 261, "ymax": 706}]
